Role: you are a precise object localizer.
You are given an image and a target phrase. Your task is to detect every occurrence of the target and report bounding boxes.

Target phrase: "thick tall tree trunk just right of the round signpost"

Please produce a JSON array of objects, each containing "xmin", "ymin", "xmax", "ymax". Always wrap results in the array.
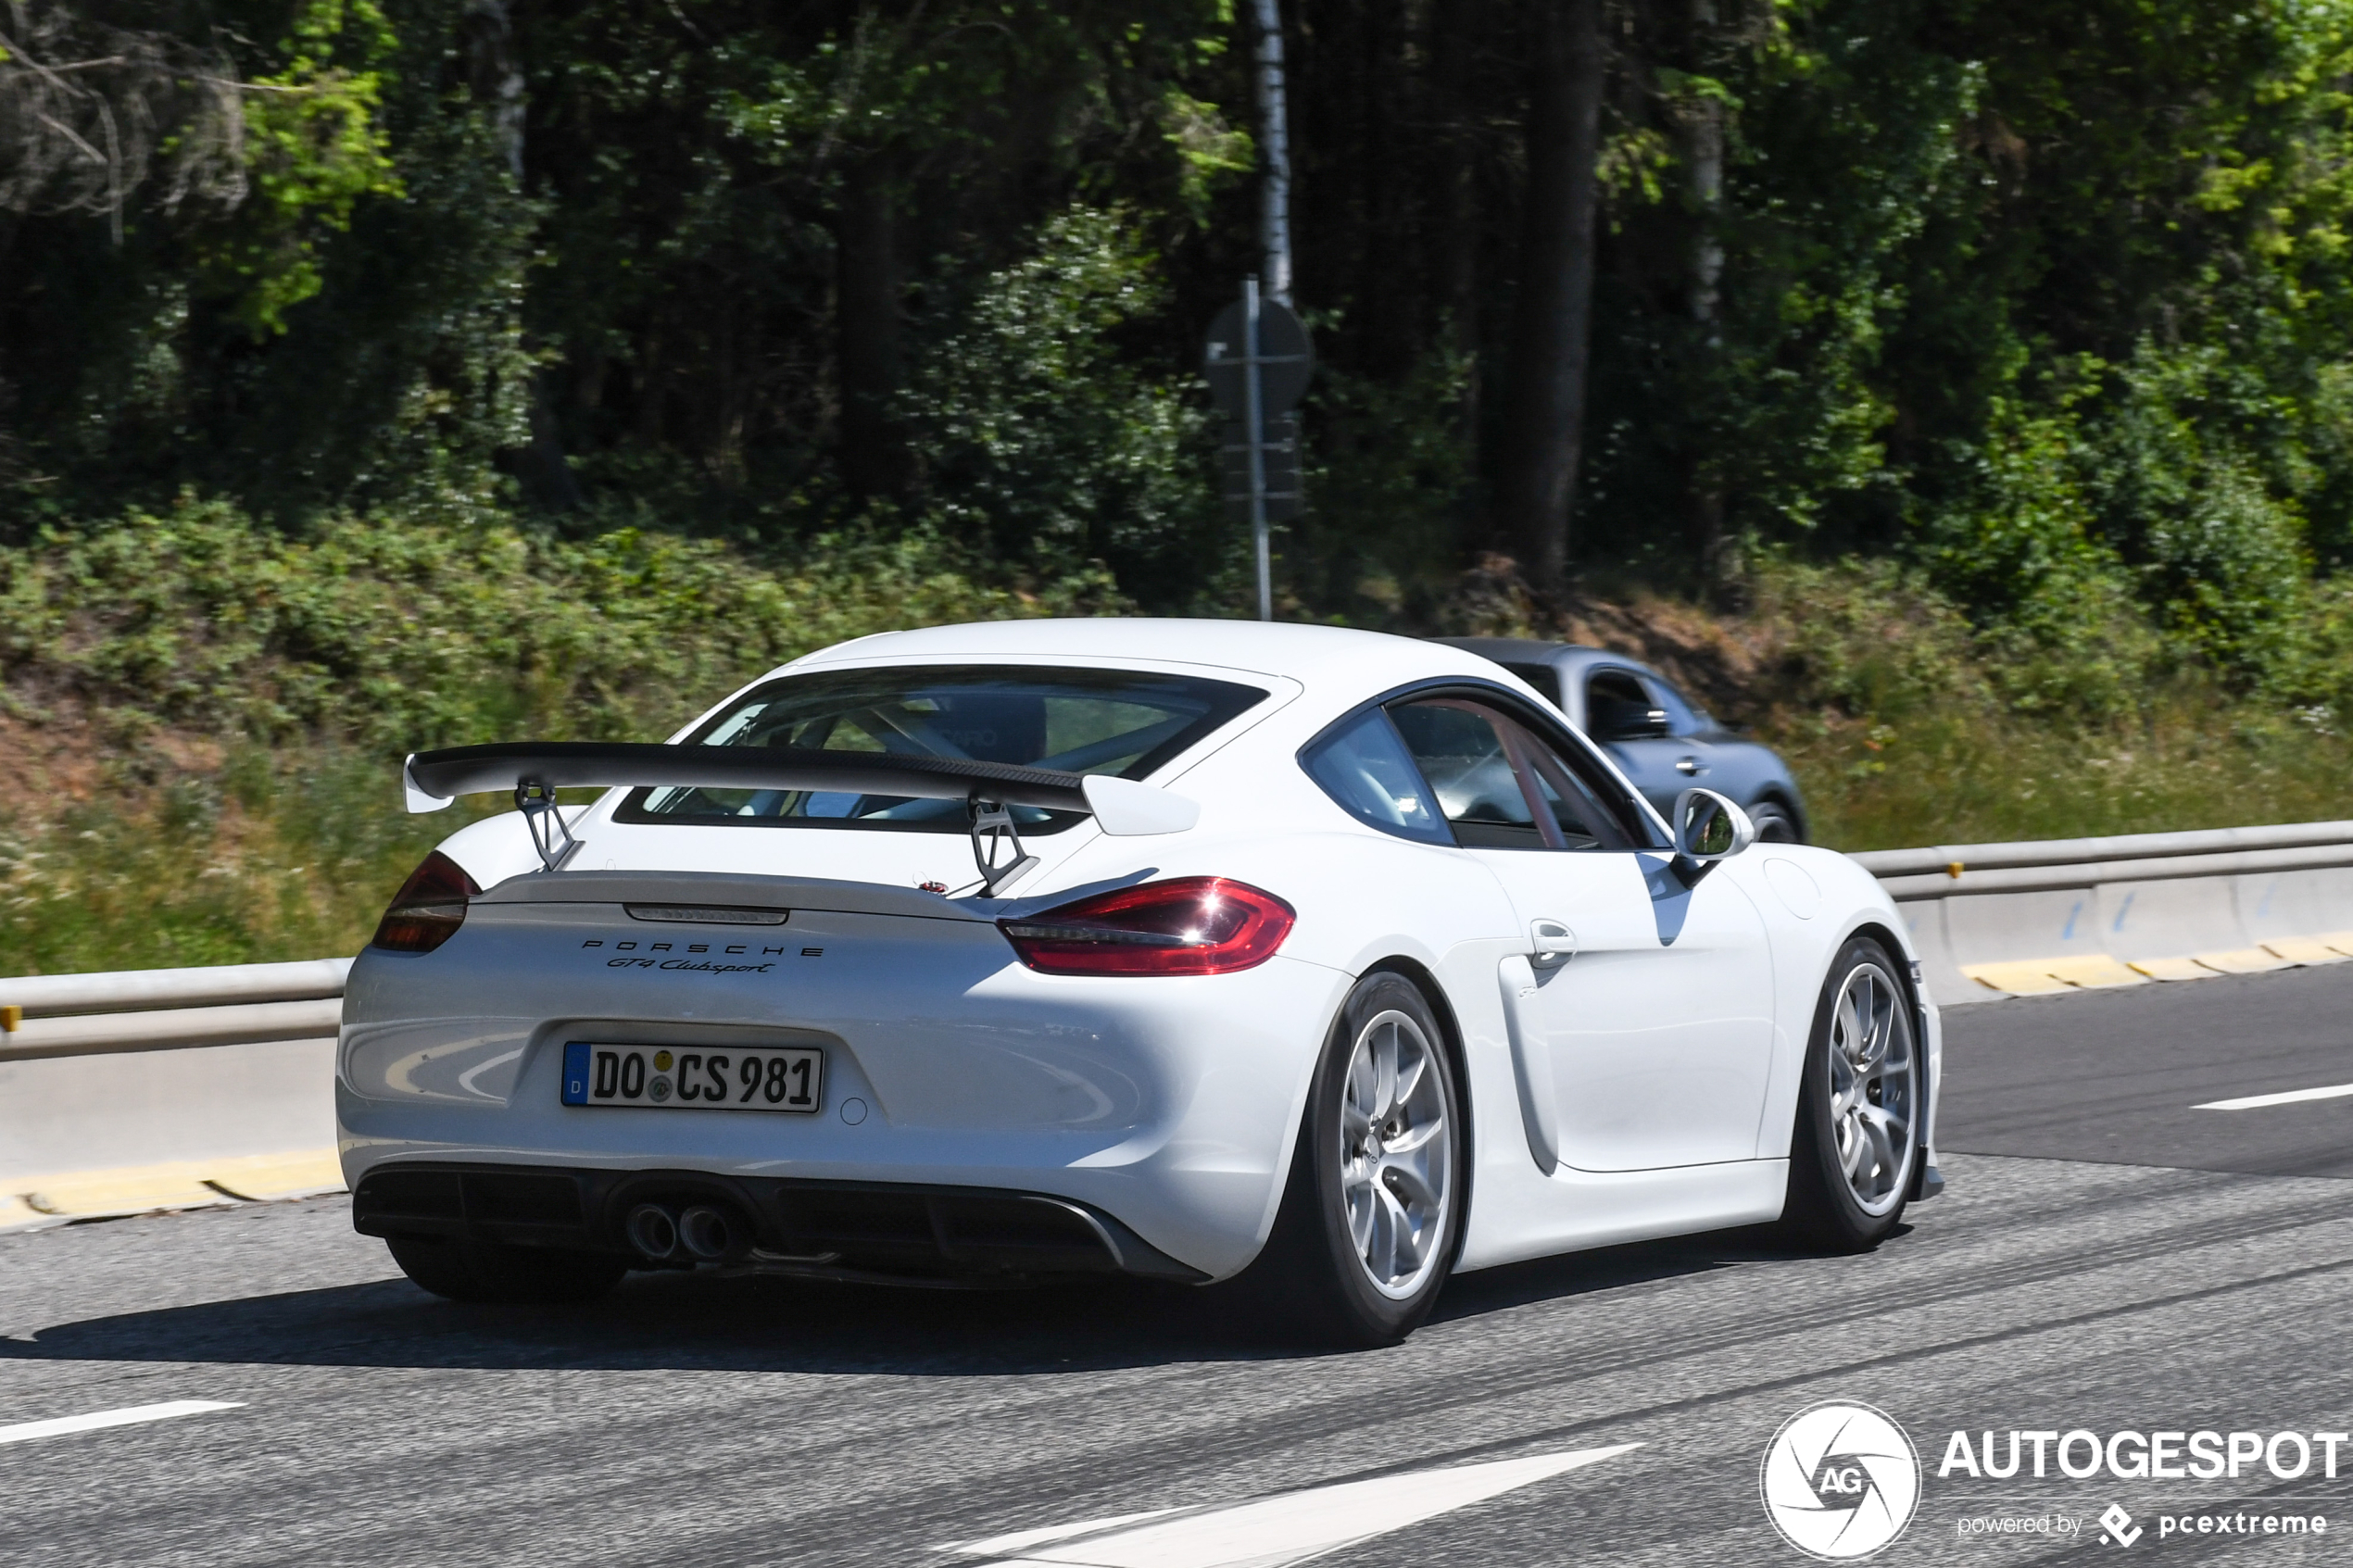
[{"xmin": 1496, "ymin": 0, "xmax": 1603, "ymax": 593}]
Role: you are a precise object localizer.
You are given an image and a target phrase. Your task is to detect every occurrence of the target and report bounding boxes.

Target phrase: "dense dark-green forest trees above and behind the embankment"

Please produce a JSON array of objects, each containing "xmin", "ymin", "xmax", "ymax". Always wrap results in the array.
[{"xmin": 13, "ymin": 0, "xmax": 2353, "ymax": 662}]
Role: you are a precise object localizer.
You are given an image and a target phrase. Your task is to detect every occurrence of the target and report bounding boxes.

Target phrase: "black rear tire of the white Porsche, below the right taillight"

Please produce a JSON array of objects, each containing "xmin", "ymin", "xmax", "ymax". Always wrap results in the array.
[{"xmin": 1236, "ymin": 971, "xmax": 1471, "ymax": 1347}]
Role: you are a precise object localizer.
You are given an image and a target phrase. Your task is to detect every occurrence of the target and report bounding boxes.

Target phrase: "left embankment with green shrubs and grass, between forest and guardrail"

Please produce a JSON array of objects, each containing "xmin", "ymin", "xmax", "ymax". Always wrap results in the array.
[{"xmin": 0, "ymin": 503, "xmax": 1120, "ymax": 973}]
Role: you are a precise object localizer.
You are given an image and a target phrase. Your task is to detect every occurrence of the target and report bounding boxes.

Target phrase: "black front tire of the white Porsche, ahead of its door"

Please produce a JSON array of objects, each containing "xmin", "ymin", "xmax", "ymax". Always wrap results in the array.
[{"xmin": 1781, "ymin": 935, "xmax": 1927, "ymax": 1253}]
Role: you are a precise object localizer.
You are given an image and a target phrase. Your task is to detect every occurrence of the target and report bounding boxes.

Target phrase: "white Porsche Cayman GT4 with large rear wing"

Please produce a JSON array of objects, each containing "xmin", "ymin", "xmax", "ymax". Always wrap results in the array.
[{"xmin": 336, "ymin": 621, "xmax": 1942, "ymax": 1342}]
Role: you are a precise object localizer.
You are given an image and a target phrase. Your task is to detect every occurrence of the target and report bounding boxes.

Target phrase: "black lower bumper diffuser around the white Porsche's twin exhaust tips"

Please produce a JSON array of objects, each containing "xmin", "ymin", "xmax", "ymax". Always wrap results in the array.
[{"xmin": 350, "ymin": 1161, "xmax": 1207, "ymax": 1284}]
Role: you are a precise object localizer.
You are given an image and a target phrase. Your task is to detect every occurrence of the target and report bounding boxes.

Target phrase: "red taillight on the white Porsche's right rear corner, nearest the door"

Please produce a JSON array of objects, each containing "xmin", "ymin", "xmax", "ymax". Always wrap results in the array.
[{"xmin": 998, "ymin": 877, "xmax": 1299, "ymax": 975}]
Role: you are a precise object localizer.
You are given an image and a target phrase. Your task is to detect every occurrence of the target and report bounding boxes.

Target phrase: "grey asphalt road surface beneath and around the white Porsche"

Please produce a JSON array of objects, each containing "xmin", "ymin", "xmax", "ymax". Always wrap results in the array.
[{"xmin": 0, "ymin": 966, "xmax": 2353, "ymax": 1568}]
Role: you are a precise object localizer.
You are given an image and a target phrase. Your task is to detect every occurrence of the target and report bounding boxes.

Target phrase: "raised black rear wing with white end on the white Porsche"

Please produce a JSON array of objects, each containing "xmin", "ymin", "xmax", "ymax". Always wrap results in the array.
[{"xmin": 400, "ymin": 741, "xmax": 1200, "ymax": 894}]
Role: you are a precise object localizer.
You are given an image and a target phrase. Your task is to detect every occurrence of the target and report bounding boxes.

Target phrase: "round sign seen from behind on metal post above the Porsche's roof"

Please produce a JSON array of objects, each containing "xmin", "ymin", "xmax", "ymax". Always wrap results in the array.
[{"xmin": 1202, "ymin": 278, "xmax": 1315, "ymax": 621}]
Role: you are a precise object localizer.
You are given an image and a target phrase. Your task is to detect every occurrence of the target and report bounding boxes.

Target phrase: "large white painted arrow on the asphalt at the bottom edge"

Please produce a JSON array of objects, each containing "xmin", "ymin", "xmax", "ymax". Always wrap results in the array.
[{"xmin": 946, "ymin": 1443, "xmax": 1642, "ymax": 1568}]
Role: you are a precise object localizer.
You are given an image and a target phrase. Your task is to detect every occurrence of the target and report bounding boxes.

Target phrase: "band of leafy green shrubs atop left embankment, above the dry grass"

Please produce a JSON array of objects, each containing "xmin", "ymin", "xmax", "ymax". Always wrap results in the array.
[{"xmin": 0, "ymin": 503, "xmax": 1120, "ymax": 752}]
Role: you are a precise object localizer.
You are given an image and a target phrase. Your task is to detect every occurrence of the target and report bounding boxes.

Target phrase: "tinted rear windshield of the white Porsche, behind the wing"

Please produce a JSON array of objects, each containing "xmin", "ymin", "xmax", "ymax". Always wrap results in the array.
[{"xmin": 616, "ymin": 665, "xmax": 1266, "ymax": 833}]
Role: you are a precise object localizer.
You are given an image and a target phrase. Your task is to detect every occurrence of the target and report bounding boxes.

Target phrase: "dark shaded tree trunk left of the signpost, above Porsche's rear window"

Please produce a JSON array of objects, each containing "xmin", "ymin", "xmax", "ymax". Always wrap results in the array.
[{"xmin": 833, "ymin": 153, "xmax": 908, "ymax": 501}]
